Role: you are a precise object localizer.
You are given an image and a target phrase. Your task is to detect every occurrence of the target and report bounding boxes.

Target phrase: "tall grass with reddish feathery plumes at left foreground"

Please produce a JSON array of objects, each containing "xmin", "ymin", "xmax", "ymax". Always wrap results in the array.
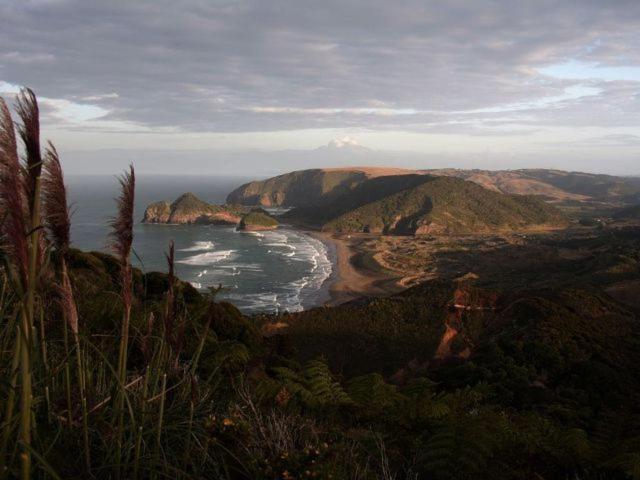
[{"xmin": 0, "ymin": 89, "xmax": 228, "ymax": 479}]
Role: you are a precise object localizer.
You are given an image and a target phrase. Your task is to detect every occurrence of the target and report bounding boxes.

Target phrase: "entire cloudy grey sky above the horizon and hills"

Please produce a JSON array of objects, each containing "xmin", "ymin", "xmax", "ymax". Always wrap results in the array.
[{"xmin": 0, "ymin": 0, "xmax": 640, "ymax": 176}]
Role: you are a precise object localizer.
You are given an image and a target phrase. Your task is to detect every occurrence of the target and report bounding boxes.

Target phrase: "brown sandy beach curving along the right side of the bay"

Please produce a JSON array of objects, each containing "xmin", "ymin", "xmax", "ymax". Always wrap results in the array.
[{"xmin": 304, "ymin": 229, "xmax": 403, "ymax": 306}]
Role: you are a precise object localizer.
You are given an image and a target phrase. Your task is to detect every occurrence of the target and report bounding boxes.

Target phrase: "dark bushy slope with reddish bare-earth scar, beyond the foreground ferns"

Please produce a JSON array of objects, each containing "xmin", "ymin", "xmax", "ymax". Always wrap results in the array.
[{"xmin": 276, "ymin": 281, "xmax": 640, "ymax": 408}]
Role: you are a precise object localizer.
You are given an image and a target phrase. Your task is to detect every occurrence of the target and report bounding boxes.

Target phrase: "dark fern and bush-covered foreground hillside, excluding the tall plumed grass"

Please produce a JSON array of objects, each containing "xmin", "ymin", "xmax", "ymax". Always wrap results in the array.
[{"xmin": 20, "ymin": 250, "xmax": 640, "ymax": 480}]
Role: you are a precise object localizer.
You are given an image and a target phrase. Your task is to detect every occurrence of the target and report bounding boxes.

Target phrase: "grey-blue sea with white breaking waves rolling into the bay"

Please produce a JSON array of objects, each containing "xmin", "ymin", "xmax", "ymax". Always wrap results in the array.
[{"xmin": 66, "ymin": 176, "xmax": 335, "ymax": 314}]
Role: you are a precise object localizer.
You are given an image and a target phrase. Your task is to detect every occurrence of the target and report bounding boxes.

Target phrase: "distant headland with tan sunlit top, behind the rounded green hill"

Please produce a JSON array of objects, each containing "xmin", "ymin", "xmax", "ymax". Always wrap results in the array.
[{"xmin": 227, "ymin": 167, "xmax": 412, "ymax": 207}]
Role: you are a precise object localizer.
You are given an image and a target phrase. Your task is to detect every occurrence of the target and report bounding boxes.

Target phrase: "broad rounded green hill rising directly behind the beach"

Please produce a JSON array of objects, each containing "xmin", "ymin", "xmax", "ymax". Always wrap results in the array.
[{"xmin": 312, "ymin": 176, "xmax": 565, "ymax": 234}]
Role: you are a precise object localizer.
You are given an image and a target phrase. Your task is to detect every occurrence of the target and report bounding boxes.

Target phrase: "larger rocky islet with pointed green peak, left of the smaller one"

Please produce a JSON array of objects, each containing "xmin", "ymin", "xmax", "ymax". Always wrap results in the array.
[{"xmin": 142, "ymin": 193, "xmax": 243, "ymax": 225}]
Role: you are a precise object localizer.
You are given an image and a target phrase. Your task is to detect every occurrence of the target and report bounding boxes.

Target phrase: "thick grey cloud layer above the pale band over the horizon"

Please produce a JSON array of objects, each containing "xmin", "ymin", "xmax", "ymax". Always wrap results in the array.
[{"xmin": 0, "ymin": 0, "xmax": 640, "ymax": 131}]
